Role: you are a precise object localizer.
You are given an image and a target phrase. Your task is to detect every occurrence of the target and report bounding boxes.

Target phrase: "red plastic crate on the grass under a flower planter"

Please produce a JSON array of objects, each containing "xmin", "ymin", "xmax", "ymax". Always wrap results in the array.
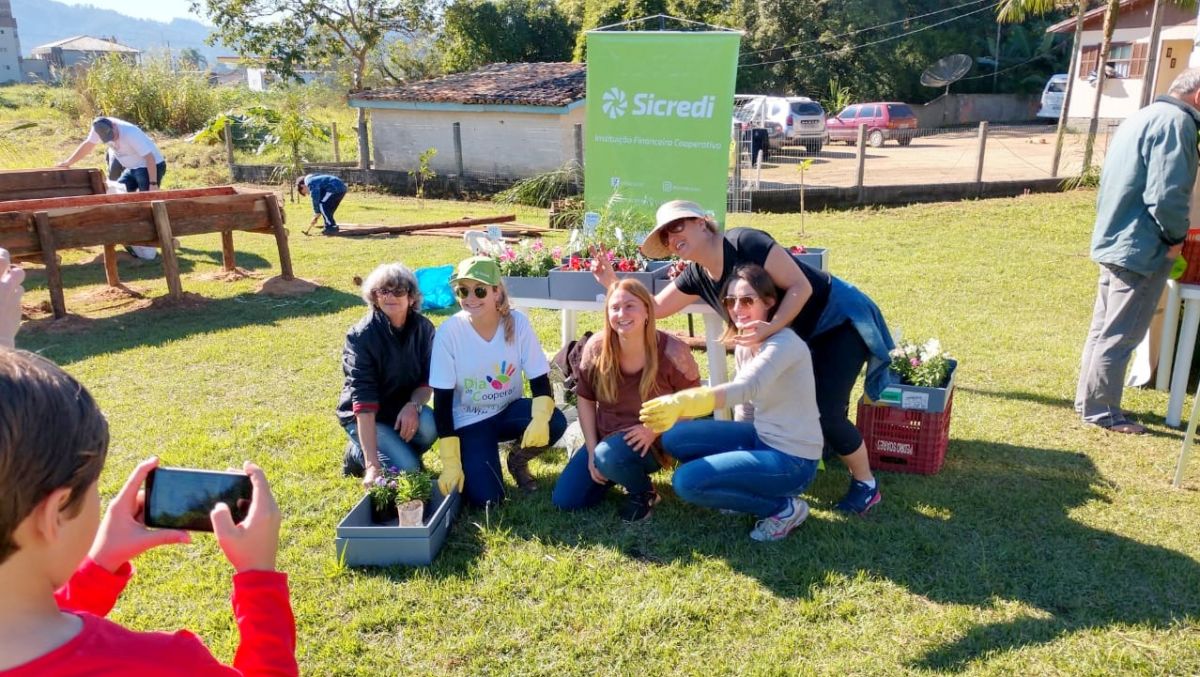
[{"xmin": 858, "ymin": 391, "xmax": 954, "ymax": 475}]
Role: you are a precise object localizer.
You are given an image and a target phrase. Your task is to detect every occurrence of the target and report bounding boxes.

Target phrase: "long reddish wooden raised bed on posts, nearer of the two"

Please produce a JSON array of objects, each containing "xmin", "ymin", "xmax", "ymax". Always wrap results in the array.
[{"xmin": 0, "ymin": 186, "xmax": 294, "ymax": 318}]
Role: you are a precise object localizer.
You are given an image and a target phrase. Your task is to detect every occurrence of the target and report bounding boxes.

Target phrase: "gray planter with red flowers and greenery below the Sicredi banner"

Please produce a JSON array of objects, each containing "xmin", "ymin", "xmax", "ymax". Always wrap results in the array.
[{"xmin": 550, "ymin": 194, "xmax": 668, "ymax": 301}]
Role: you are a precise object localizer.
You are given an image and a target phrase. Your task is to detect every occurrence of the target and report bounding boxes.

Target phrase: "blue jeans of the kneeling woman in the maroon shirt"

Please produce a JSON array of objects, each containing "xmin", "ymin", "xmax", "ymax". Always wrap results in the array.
[{"xmin": 551, "ymin": 432, "xmax": 661, "ymax": 510}]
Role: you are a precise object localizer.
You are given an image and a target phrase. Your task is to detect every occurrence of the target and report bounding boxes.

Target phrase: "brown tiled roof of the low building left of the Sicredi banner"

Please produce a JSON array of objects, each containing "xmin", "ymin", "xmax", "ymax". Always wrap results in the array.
[{"xmin": 352, "ymin": 62, "xmax": 587, "ymax": 107}]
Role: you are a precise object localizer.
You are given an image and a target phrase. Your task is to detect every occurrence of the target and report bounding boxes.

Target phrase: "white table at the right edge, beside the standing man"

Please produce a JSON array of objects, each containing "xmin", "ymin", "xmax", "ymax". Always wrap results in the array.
[{"xmin": 1154, "ymin": 280, "xmax": 1200, "ymax": 426}]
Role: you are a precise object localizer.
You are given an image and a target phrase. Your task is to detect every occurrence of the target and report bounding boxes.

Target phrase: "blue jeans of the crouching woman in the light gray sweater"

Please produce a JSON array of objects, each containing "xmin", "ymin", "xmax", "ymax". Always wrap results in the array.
[{"xmin": 662, "ymin": 419, "xmax": 817, "ymax": 517}]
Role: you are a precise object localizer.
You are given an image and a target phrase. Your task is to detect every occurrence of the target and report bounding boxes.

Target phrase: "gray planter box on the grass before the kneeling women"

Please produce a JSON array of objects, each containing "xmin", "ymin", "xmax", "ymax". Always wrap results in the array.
[{"xmin": 334, "ymin": 484, "xmax": 462, "ymax": 567}]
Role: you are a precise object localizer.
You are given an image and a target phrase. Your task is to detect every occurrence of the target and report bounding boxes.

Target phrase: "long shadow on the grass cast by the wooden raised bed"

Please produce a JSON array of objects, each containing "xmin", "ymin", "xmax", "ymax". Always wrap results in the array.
[{"xmin": 17, "ymin": 287, "xmax": 362, "ymax": 366}]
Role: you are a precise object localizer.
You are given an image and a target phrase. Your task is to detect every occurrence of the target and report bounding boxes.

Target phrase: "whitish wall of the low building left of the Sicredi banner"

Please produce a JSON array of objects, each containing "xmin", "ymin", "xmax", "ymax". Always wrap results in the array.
[{"xmin": 371, "ymin": 106, "xmax": 584, "ymax": 179}]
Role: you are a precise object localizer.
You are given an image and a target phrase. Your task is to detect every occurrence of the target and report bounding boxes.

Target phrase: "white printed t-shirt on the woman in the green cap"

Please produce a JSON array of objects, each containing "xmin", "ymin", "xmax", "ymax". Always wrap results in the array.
[{"xmin": 430, "ymin": 311, "xmax": 550, "ymax": 430}]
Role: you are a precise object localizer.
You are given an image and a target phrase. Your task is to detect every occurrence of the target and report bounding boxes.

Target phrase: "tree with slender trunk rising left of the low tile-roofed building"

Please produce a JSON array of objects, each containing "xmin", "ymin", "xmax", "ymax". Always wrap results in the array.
[{"xmin": 192, "ymin": 0, "xmax": 436, "ymax": 168}]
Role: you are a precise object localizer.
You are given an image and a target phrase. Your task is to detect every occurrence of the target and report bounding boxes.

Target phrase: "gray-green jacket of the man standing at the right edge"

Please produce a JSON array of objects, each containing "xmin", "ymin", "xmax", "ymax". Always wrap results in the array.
[{"xmin": 1092, "ymin": 96, "xmax": 1200, "ymax": 275}]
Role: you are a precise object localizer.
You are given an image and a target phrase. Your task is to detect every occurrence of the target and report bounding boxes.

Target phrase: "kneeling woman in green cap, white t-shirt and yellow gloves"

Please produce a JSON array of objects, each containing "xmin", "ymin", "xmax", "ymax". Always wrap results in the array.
[{"xmin": 430, "ymin": 256, "xmax": 566, "ymax": 505}]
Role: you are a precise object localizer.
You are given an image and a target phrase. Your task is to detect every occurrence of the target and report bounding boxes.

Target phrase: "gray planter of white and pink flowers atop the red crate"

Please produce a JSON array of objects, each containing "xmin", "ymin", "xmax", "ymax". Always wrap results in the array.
[{"xmin": 878, "ymin": 339, "xmax": 958, "ymax": 412}]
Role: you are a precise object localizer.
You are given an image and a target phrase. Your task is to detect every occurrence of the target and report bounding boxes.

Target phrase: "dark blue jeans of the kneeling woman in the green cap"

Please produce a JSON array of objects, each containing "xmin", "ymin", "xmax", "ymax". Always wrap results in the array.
[{"xmin": 455, "ymin": 397, "xmax": 566, "ymax": 505}]
